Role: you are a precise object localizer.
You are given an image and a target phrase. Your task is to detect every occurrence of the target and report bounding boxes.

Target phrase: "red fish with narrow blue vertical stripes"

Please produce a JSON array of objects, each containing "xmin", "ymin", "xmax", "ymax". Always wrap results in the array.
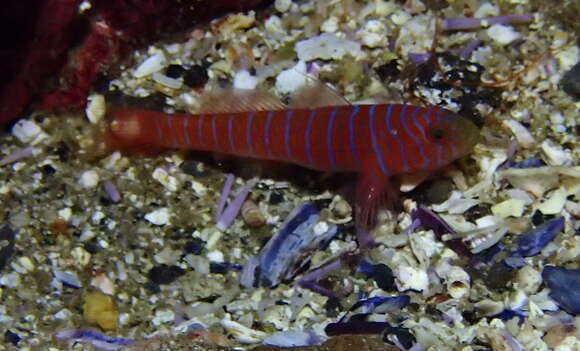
[{"xmin": 107, "ymin": 91, "xmax": 479, "ymax": 232}]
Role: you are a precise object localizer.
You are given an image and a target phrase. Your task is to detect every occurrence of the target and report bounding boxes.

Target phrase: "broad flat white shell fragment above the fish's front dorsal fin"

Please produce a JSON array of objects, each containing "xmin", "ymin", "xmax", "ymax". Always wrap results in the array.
[{"xmin": 296, "ymin": 33, "xmax": 362, "ymax": 61}]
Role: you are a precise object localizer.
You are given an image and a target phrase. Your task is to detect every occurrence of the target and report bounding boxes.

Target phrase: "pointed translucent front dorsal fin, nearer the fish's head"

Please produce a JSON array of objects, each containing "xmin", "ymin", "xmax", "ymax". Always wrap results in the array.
[{"xmin": 289, "ymin": 80, "xmax": 350, "ymax": 109}]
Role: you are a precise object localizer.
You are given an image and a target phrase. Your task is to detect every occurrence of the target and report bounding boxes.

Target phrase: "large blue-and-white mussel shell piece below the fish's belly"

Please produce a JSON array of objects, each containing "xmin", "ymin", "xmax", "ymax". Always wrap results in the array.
[{"xmin": 242, "ymin": 203, "xmax": 338, "ymax": 287}]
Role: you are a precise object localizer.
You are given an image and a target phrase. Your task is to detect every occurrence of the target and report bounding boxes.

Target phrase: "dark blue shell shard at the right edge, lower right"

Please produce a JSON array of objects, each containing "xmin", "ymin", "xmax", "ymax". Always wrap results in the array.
[{"xmin": 542, "ymin": 266, "xmax": 580, "ymax": 315}]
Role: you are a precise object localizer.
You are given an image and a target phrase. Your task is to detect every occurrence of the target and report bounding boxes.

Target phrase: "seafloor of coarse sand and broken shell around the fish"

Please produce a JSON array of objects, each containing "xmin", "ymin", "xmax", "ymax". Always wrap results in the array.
[{"xmin": 0, "ymin": 0, "xmax": 580, "ymax": 351}]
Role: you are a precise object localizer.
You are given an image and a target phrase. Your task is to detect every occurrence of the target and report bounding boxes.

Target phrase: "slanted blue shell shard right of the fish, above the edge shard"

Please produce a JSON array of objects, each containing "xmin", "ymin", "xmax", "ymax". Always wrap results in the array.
[{"xmin": 514, "ymin": 217, "xmax": 564, "ymax": 257}]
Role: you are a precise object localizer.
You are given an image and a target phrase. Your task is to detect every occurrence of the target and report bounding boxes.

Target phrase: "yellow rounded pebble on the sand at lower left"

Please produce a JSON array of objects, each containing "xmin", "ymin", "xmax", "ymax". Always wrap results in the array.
[{"xmin": 83, "ymin": 291, "xmax": 119, "ymax": 330}]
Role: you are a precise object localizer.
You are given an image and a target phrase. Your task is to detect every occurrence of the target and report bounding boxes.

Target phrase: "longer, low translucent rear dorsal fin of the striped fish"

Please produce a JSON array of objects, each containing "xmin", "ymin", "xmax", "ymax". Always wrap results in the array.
[{"xmin": 200, "ymin": 89, "xmax": 287, "ymax": 113}]
